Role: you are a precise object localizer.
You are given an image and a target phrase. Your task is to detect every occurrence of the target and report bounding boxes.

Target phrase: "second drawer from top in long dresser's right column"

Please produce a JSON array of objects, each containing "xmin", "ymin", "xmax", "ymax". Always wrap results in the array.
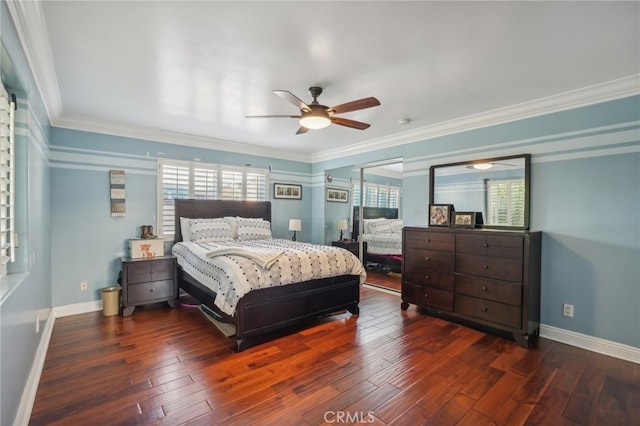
[{"xmin": 456, "ymin": 254, "xmax": 522, "ymax": 283}]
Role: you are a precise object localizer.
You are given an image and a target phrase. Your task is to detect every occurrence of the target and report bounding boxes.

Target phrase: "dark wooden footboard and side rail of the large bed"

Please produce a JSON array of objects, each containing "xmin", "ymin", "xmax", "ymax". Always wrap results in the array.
[{"xmin": 178, "ymin": 268, "xmax": 360, "ymax": 352}]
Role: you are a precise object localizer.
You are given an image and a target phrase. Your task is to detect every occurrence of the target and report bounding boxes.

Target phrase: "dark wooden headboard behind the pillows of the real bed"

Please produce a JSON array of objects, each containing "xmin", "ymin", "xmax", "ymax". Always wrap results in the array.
[{"xmin": 175, "ymin": 200, "xmax": 271, "ymax": 243}]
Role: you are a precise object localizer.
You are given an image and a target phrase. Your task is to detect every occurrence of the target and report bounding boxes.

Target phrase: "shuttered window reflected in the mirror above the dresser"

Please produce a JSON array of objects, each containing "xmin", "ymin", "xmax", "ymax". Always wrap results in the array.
[{"xmin": 486, "ymin": 179, "xmax": 525, "ymax": 226}]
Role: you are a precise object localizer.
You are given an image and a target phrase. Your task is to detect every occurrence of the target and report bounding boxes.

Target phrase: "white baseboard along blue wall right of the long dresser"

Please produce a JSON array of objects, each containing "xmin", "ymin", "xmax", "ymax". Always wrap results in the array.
[{"xmin": 540, "ymin": 324, "xmax": 640, "ymax": 364}]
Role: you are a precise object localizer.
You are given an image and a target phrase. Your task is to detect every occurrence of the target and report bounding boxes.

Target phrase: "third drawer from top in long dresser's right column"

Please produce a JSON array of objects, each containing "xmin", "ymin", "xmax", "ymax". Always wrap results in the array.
[{"xmin": 455, "ymin": 274, "xmax": 522, "ymax": 306}]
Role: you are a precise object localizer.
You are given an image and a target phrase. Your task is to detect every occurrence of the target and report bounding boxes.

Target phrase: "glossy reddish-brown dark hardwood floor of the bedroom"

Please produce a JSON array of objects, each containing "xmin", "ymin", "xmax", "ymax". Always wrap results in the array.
[{"xmin": 30, "ymin": 288, "xmax": 640, "ymax": 426}]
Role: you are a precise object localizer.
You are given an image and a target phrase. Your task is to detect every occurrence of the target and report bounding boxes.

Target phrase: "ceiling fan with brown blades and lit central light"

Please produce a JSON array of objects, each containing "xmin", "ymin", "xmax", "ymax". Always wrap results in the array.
[{"xmin": 246, "ymin": 86, "xmax": 380, "ymax": 135}]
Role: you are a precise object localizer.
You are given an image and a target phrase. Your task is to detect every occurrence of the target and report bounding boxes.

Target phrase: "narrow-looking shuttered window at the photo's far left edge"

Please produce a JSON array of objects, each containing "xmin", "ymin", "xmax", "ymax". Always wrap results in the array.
[{"xmin": 0, "ymin": 83, "xmax": 16, "ymax": 277}]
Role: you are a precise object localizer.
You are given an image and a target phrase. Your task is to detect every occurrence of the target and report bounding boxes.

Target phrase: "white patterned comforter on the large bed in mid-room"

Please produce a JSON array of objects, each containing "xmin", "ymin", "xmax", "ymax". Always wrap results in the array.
[{"xmin": 172, "ymin": 238, "xmax": 367, "ymax": 315}]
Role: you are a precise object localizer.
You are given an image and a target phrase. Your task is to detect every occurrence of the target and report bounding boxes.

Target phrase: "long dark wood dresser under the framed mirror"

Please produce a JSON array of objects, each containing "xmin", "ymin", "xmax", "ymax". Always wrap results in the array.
[{"xmin": 401, "ymin": 227, "xmax": 542, "ymax": 347}]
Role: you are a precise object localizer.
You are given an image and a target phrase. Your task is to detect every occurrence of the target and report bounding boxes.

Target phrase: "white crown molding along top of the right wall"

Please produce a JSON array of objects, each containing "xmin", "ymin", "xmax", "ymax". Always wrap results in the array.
[{"xmin": 311, "ymin": 74, "xmax": 640, "ymax": 163}]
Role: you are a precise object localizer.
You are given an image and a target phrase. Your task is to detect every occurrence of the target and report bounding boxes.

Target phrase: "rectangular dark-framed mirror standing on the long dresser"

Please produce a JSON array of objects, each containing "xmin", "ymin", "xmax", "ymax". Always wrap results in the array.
[{"xmin": 429, "ymin": 154, "xmax": 531, "ymax": 229}]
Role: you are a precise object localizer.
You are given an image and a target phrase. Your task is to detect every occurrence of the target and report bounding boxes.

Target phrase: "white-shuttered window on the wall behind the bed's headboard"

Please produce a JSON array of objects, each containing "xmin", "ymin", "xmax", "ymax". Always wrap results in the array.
[{"xmin": 158, "ymin": 160, "xmax": 269, "ymax": 236}]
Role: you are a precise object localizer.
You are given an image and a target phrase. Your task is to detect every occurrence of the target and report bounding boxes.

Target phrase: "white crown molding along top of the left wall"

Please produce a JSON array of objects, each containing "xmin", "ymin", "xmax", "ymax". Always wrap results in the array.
[{"xmin": 5, "ymin": 0, "xmax": 62, "ymax": 123}]
